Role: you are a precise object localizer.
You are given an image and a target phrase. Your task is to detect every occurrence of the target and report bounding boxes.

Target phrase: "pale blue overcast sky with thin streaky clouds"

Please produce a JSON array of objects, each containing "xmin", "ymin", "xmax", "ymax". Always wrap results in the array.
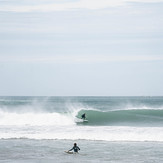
[{"xmin": 0, "ymin": 0, "xmax": 163, "ymax": 96}]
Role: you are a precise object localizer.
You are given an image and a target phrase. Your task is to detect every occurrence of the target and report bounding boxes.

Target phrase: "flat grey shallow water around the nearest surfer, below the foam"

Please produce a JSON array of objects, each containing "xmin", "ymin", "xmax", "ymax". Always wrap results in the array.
[{"xmin": 0, "ymin": 139, "xmax": 163, "ymax": 163}]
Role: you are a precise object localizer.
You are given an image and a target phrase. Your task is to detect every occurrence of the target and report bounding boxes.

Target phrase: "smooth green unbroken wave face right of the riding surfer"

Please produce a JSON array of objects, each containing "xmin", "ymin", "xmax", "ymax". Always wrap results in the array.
[{"xmin": 77, "ymin": 109, "xmax": 163, "ymax": 126}]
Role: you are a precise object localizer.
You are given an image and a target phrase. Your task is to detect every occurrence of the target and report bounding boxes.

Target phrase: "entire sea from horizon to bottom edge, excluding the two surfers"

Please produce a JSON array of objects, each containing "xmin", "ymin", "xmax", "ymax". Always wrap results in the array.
[{"xmin": 0, "ymin": 97, "xmax": 163, "ymax": 163}]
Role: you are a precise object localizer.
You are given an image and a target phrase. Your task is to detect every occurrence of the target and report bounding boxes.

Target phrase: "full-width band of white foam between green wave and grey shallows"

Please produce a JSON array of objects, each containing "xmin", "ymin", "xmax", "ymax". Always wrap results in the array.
[{"xmin": 0, "ymin": 125, "xmax": 163, "ymax": 142}]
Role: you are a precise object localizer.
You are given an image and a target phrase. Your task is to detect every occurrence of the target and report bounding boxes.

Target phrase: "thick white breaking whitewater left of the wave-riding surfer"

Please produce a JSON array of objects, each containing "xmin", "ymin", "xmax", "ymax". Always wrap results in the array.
[{"xmin": 0, "ymin": 111, "xmax": 75, "ymax": 126}]
